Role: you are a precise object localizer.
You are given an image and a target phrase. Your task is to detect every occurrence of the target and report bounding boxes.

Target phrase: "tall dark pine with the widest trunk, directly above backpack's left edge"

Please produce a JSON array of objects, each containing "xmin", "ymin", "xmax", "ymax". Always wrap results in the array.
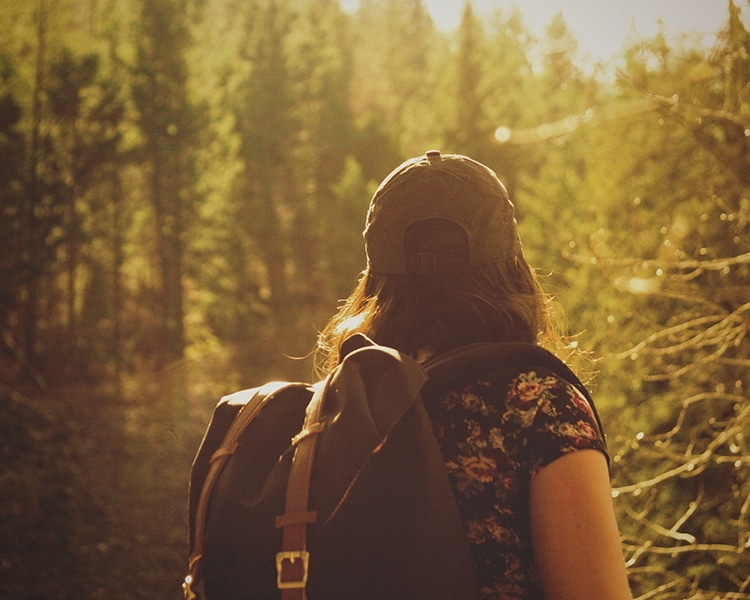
[{"xmin": 132, "ymin": 0, "xmax": 199, "ymax": 362}]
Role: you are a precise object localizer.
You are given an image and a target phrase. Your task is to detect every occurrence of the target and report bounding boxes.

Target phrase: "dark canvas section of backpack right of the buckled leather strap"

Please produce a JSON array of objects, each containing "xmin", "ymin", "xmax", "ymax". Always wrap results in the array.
[{"xmin": 307, "ymin": 346, "xmax": 484, "ymax": 600}]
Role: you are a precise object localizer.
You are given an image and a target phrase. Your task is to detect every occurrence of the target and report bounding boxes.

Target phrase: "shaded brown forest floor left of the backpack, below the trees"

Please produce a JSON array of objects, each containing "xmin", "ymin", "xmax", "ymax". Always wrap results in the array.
[{"xmin": 0, "ymin": 372, "xmax": 215, "ymax": 600}]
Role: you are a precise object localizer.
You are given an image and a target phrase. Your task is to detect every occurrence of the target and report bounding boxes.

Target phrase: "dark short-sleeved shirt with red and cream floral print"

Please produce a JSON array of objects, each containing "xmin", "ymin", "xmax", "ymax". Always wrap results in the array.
[{"xmin": 425, "ymin": 368, "xmax": 606, "ymax": 600}]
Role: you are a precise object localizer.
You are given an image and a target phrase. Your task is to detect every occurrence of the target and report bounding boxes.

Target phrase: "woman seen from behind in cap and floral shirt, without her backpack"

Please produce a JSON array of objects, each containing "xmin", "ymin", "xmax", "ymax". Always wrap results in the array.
[{"xmin": 318, "ymin": 150, "xmax": 631, "ymax": 600}]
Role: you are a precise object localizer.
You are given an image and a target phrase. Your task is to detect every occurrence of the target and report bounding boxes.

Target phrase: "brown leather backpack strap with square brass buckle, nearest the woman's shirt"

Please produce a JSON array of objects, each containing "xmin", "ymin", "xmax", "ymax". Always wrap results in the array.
[{"xmin": 276, "ymin": 375, "xmax": 331, "ymax": 600}]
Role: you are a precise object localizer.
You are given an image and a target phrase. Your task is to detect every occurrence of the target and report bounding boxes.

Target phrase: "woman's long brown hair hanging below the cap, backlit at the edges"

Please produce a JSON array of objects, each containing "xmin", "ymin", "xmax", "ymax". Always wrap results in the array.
[{"xmin": 315, "ymin": 256, "xmax": 561, "ymax": 375}]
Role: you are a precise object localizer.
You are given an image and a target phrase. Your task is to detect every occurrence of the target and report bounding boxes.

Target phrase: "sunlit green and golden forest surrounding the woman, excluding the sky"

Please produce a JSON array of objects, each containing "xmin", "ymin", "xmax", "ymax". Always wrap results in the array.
[{"xmin": 0, "ymin": 0, "xmax": 750, "ymax": 600}]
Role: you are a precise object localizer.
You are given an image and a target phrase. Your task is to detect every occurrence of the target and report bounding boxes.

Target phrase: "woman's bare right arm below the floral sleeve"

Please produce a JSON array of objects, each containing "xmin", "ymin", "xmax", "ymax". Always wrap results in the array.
[{"xmin": 529, "ymin": 450, "xmax": 632, "ymax": 600}]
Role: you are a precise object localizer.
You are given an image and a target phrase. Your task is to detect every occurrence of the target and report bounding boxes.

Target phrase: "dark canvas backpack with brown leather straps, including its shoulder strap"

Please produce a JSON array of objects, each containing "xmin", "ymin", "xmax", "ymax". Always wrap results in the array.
[{"xmin": 183, "ymin": 334, "xmax": 601, "ymax": 600}]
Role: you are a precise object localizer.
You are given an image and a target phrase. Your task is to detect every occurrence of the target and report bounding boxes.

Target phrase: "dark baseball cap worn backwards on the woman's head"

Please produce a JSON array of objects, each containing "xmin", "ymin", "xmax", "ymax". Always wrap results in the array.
[{"xmin": 364, "ymin": 150, "xmax": 522, "ymax": 275}]
